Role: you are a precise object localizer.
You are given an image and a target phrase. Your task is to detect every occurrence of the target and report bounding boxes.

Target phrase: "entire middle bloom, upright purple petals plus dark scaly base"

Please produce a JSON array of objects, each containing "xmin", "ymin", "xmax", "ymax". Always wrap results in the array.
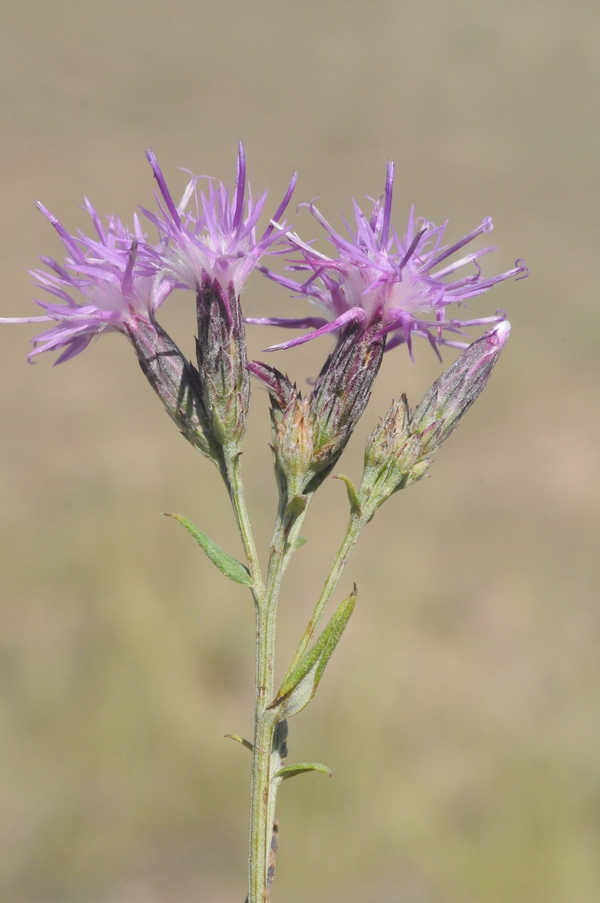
[{"xmin": 144, "ymin": 144, "xmax": 296, "ymax": 454}]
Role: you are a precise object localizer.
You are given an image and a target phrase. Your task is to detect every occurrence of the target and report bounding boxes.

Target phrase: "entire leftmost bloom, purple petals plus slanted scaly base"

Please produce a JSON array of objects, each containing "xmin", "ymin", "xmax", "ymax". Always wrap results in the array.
[{"xmin": 0, "ymin": 199, "xmax": 221, "ymax": 466}]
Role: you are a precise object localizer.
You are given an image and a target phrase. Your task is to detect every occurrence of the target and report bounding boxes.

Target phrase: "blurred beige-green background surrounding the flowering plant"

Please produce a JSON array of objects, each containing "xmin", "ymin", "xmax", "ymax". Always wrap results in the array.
[{"xmin": 0, "ymin": 0, "xmax": 600, "ymax": 903}]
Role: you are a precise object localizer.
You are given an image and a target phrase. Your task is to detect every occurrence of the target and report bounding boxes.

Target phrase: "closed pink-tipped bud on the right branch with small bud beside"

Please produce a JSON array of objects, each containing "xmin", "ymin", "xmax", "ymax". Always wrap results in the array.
[{"xmin": 358, "ymin": 320, "xmax": 510, "ymax": 517}]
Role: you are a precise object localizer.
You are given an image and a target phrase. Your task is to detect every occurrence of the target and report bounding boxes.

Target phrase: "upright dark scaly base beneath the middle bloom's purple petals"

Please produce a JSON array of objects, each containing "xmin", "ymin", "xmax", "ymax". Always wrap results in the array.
[{"xmin": 196, "ymin": 273, "xmax": 250, "ymax": 446}]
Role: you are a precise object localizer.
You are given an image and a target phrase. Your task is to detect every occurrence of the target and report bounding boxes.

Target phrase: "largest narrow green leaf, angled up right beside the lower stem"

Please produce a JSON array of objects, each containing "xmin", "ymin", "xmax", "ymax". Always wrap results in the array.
[{"xmin": 269, "ymin": 586, "xmax": 356, "ymax": 718}]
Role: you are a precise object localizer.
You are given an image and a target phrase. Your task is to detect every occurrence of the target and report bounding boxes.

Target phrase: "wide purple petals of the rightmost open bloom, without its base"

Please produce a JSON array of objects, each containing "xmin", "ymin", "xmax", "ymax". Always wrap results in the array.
[{"xmin": 247, "ymin": 162, "xmax": 527, "ymax": 357}]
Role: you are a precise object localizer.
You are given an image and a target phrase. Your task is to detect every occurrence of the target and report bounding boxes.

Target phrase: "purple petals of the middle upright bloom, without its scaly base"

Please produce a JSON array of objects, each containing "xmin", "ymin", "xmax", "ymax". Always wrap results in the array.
[{"xmin": 143, "ymin": 144, "xmax": 296, "ymax": 297}]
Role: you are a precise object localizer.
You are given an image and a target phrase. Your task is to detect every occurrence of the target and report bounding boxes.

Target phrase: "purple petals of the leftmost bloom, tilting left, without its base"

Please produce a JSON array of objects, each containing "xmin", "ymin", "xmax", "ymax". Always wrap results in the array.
[{"xmin": 0, "ymin": 198, "xmax": 174, "ymax": 364}]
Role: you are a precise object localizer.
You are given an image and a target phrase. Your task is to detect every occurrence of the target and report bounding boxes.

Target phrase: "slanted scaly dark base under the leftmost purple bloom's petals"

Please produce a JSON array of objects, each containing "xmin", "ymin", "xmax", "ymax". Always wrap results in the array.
[{"xmin": 127, "ymin": 317, "xmax": 221, "ymax": 467}]
